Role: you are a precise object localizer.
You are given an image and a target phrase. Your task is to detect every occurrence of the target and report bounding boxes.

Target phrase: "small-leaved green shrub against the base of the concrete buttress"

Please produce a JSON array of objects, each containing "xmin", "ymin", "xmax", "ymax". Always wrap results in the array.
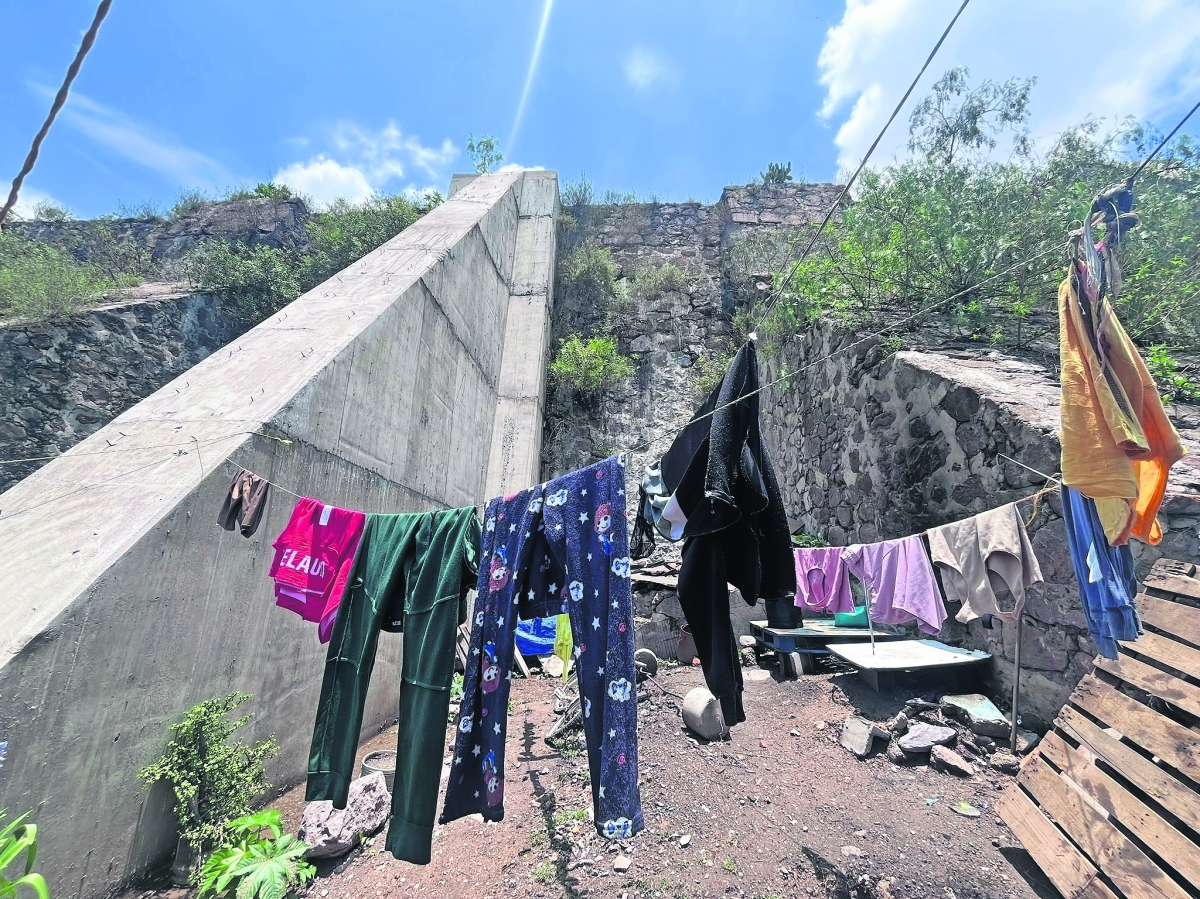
[{"xmin": 138, "ymin": 693, "xmax": 278, "ymax": 855}]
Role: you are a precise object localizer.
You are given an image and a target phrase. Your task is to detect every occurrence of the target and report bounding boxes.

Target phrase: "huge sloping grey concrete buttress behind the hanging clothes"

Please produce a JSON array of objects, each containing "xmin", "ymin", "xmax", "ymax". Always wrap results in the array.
[{"xmin": 0, "ymin": 173, "xmax": 557, "ymax": 897}]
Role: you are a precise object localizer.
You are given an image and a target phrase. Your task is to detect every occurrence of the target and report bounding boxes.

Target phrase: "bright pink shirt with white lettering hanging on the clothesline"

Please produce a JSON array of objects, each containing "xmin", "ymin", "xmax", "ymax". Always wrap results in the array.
[{"xmin": 269, "ymin": 497, "xmax": 366, "ymax": 643}]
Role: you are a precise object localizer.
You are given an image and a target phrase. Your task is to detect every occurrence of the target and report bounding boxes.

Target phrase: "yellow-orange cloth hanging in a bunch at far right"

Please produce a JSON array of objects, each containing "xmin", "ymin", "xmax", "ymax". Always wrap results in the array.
[{"xmin": 1058, "ymin": 270, "xmax": 1184, "ymax": 546}]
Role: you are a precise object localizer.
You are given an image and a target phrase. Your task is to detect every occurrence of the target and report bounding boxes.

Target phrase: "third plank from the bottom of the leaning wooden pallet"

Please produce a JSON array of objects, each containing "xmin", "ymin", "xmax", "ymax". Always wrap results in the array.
[{"xmin": 1038, "ymin": 733, "xmax": 1200, "ymax": 883}]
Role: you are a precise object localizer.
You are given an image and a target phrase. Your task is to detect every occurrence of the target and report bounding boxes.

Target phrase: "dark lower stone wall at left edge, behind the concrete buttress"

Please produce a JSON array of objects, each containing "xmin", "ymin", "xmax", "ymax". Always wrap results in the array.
[{"xmin": 0, "ymin": 286, "xmax": 244, "ymax": 492}]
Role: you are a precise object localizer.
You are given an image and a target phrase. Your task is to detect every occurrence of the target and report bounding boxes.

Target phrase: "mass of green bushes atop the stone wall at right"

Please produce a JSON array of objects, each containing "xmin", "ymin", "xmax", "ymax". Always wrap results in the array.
[{"xmin": 757, "ymin": 68, "xmax": 1200, "ymax": 393}]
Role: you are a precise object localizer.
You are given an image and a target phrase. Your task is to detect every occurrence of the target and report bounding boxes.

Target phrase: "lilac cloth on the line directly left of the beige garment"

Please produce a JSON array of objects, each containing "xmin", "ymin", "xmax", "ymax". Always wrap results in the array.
[{"xmin": 841, "ymin": 537, "xmax": 946, "ymax": 634}]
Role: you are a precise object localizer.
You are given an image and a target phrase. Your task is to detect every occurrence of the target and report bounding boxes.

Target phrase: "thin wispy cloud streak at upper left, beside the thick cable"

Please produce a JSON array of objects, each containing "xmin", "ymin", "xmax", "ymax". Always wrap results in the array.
[{"xmin": 30, "ymin": 84, "xmax": 236, "ymax": 188}]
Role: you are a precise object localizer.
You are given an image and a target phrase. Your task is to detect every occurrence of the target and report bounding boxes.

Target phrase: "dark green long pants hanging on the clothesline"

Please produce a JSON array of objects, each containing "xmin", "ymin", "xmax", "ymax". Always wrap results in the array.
[{"xmin": 305, "ymin": 508, "xmax": 480, "ymax": 864}]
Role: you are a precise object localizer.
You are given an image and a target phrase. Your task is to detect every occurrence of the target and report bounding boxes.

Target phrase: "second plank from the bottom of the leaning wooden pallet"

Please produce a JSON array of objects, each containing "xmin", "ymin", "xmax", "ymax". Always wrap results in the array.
[{"xmin": 1019, "ymin": 756, "xmax": 1189, "ymax": 899}]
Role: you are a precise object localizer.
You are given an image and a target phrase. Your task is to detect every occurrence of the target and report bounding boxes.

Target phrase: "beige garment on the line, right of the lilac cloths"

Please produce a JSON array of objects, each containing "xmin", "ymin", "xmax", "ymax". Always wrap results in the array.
[{"xmin": 929, "ymin": 503, "xmax": 1042, "ymax": 624}]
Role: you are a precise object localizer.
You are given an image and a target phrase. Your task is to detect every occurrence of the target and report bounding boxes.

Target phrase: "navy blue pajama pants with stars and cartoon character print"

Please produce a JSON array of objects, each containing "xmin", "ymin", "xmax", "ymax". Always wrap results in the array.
[{"xmin": 438, "ymin": 455, "xmax": 644, "ymax": 838}]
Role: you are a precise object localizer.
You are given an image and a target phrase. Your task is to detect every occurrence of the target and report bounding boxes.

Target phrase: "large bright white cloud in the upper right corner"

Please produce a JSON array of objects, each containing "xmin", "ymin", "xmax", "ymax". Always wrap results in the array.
[{"xmin": 817, "ymin": 0, "xmax": 1200, "ymax": 167}]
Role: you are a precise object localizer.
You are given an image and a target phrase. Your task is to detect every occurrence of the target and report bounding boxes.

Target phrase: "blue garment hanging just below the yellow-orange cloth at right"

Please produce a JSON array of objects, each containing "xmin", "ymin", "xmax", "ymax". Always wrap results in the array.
[{"xmin": 1062, "ymin": 485, "xmax": 1142, "ymax": 659}]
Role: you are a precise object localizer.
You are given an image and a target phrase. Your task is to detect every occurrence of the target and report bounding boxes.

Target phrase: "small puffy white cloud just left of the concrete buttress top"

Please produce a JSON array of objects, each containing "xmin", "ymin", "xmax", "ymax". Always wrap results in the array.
[{"xmin": 272, "ymin": 121, "xmax": 458, "ymax": 205}]
